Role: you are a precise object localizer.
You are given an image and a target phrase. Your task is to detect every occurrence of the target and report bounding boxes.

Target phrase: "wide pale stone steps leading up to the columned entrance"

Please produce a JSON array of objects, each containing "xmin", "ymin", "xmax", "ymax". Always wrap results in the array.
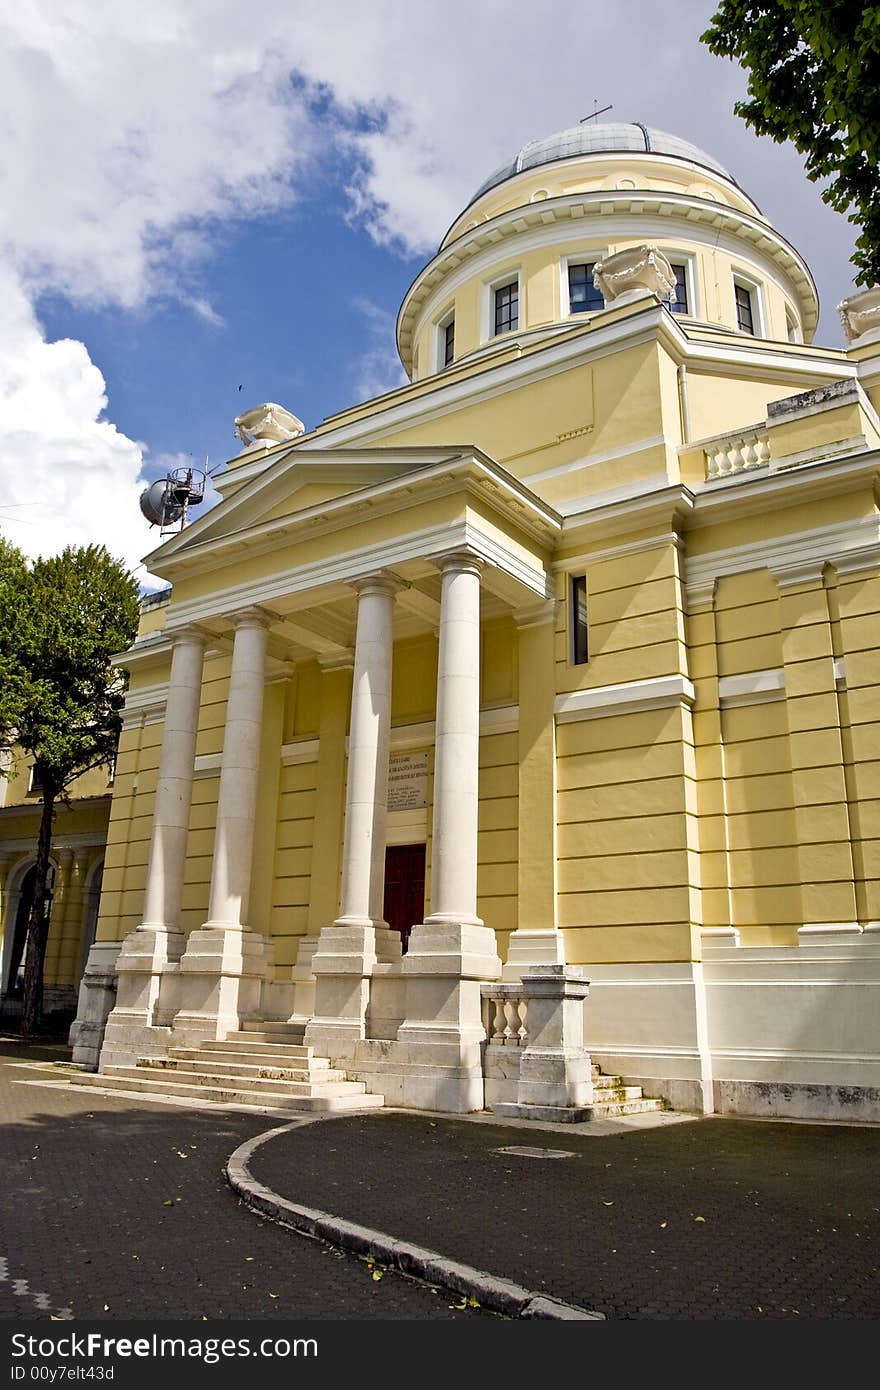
[{"xmin": 71, "ymin": 1023, "xmax": 384, "ymax": 1113}]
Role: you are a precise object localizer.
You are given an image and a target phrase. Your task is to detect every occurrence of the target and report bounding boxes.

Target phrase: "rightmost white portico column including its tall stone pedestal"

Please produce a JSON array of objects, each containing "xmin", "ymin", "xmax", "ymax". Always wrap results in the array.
[{"xmin": 398, "ymin": 553, "xmax": 500, "ymax": 1111}]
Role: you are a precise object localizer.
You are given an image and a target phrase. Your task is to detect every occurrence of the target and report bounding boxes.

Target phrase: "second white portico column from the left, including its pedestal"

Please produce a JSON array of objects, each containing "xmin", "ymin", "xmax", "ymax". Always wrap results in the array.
[{"xmin": 174, "ymin": 609, "xmax": 271, "ymax": 1047}]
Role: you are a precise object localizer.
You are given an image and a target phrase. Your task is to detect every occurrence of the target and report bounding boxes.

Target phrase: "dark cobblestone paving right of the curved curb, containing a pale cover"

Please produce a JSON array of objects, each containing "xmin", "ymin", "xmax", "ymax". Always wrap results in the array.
[{"xmin": 250, "ymin": 1112, "xmax": 880, "ymax": 1319}]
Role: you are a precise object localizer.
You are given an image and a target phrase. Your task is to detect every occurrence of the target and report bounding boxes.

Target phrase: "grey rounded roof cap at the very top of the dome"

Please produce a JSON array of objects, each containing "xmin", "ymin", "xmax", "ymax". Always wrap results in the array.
[{"xmin": 468, "ymin": 121, "xmax": 737, "ymax": 206}]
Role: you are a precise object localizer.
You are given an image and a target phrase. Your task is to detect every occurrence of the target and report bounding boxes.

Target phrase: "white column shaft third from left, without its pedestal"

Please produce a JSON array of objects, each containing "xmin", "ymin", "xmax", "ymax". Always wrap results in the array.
[{"xmin": 336, "ymin": 574, "xmax": 399, "ymax": 927}]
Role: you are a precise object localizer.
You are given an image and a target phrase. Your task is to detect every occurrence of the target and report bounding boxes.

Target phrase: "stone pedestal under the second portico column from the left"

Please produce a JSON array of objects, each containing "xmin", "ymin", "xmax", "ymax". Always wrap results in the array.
[{"xmin": 172, "ymin": 923, "xmax": 271, "ymax": 1047}]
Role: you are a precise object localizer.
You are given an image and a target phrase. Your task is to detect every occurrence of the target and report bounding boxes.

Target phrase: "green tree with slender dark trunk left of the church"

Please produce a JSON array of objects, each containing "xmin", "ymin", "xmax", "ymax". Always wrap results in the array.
[{"xmin": 0, "ymin": 539, "xmax": 139, "ymax": 1034}]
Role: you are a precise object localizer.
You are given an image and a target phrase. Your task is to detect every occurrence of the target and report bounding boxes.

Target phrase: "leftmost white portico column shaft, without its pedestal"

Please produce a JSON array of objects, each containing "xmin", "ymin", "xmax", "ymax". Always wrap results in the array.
[{"xmin": 138, "ymin": 628, "xmax": 204, "ymax": 935}]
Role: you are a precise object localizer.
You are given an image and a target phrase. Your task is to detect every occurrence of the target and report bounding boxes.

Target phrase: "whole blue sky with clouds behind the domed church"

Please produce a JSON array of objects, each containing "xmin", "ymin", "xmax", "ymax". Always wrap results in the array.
[{"xmin": 0, "ymin": 0, "xmax": 854, "ymax": 586}]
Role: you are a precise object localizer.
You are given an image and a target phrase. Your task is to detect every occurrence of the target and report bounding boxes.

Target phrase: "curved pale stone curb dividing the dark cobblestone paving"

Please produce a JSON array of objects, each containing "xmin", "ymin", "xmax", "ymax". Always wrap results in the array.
[{"xmin": 224, "ymin": 1116, "xmax": 605, "ymax": 1322}]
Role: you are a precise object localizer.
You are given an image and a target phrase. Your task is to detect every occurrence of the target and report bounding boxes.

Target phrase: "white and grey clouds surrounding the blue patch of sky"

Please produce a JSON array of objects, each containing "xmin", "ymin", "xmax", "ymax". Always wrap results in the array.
[{"xmin": 0, "ymin": 0, "xmax": 854, "ymax": 563}]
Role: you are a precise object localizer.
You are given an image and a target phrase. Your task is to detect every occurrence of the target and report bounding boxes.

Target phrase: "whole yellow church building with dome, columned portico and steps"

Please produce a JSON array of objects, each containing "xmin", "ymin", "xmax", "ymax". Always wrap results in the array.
[{"xmin": 67, "ymin": 122, "xmax": 880, "ymax": 1120}]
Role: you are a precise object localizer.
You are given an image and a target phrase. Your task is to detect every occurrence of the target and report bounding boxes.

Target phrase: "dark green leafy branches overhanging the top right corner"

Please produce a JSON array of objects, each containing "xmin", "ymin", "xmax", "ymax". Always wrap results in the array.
[{"xmin": 701, "ymin": 0, "xmax": 880, "ymax": 285}]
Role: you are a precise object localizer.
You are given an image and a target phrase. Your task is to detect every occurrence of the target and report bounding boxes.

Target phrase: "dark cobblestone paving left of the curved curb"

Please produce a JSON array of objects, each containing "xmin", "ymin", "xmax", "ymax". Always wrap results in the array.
[{"xmin": 0, "ymin": 1041, "xmax": 494, "ymax": 1321}]
